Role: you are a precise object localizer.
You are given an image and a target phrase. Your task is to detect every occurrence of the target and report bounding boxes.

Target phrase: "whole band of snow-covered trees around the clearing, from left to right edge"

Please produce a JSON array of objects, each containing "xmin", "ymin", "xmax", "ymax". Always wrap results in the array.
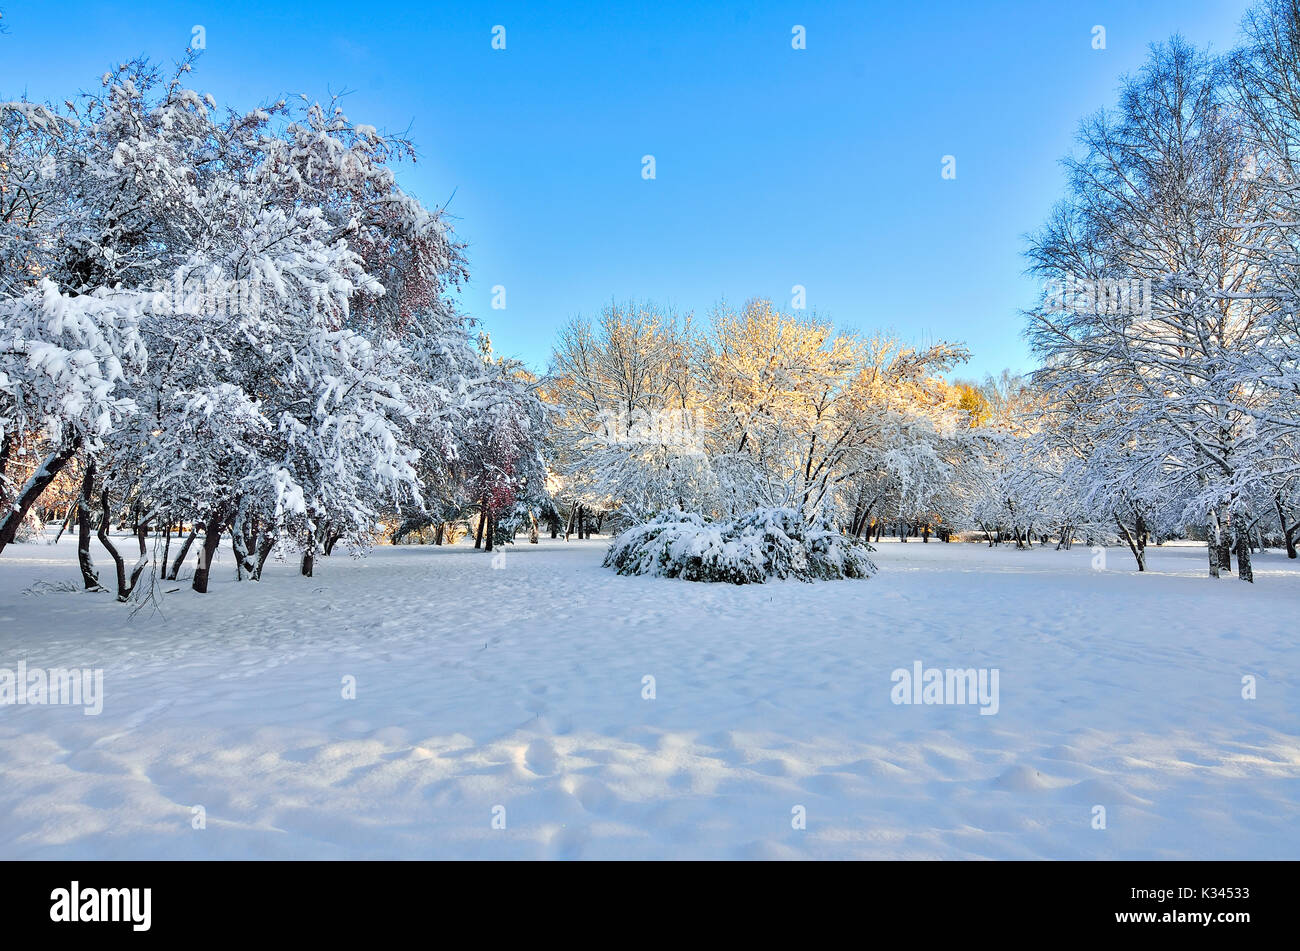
[{"xmin": 0, "ymin": 0, "xmax": 1300, "ymax": 600}]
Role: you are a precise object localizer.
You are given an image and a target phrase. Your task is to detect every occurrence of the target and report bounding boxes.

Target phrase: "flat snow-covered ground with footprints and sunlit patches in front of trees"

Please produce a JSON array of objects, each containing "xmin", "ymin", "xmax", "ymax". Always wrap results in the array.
[{"xmin": 0, "ymin": 540, "xmax": 1300, "ymax": 859}]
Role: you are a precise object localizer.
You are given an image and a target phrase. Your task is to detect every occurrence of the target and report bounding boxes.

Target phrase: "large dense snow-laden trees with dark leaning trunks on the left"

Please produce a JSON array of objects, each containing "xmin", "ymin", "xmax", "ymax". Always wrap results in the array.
[{"xmin": 0, "ymin": 60, "xmax": 522, "ymax": 596}]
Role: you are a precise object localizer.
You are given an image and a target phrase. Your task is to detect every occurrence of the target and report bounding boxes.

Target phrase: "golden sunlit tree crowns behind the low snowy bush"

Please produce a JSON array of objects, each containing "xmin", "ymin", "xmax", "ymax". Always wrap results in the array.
[{"xmin": 543, "ymin": 299, "xmax": 974, "ymax": 511}]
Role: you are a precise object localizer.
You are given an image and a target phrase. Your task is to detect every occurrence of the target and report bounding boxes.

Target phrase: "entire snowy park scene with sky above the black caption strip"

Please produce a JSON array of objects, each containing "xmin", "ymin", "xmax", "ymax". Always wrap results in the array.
[{"xmin": 0, "ymin": 0, "xmax": 1300, "ymax": 878}]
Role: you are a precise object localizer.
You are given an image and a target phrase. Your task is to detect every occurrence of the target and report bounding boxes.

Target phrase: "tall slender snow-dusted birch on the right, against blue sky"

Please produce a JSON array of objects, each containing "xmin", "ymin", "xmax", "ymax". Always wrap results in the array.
[{"xmin": 1030, "ymin": 39, "xmax": 1270, "ymax": 581}]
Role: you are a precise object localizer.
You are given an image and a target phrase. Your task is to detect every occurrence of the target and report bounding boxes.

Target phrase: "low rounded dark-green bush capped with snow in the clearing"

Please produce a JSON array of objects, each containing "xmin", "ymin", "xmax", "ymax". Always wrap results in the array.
[{"xmin": 605, "ymin": 508, "xmax": 876, "ymax": 585}]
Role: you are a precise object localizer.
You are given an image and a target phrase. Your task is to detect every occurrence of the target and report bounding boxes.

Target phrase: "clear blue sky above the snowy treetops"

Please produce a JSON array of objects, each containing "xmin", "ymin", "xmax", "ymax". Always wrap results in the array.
[{"xmin": 0, "ymin": 0, "xmax": 1247, "ymax": 375}]
